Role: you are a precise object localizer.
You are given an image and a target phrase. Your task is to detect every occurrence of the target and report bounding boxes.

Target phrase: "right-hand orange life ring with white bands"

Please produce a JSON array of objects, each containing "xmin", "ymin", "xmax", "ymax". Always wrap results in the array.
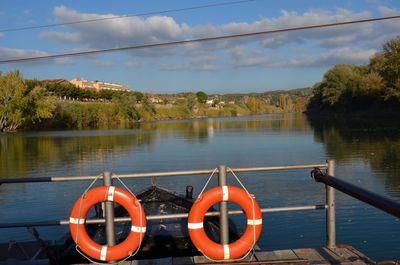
[{"xmin": 188, "ymin": 186, "xmax": 262, "ymax": 260}]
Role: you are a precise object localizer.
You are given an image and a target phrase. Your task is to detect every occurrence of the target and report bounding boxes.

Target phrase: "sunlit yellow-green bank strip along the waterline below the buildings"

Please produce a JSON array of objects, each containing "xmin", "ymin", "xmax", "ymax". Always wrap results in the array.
[{"xmin": 23, "ymin": 101, "xmax": 283, "ymax": 130}]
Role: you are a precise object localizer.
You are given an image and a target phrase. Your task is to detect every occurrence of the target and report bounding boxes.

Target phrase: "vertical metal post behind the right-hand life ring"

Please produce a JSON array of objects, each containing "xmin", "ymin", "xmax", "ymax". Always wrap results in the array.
[{"xmin": 218, "ymin": 165, "xmax": 229, "ymax": 245}]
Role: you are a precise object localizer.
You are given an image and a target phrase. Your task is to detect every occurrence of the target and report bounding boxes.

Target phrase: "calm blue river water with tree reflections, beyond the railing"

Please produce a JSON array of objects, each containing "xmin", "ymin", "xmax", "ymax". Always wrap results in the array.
[{"xmin": 0, "ymin": 114, "xmax": 400, "ymax": 260}]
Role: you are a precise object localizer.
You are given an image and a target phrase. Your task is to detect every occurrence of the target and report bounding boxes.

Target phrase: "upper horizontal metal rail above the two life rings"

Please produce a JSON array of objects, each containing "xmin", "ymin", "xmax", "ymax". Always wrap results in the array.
[{"xmin": 0, "ymin": 163, "xmax": 327, "ymax": 185}]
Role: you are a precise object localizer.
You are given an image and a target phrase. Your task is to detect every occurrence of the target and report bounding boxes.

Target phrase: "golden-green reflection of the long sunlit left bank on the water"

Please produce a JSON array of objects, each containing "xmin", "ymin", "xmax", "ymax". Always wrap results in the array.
[{"xmin": 0, "ymin": 114, "xmax": 310, "ymax": 178}]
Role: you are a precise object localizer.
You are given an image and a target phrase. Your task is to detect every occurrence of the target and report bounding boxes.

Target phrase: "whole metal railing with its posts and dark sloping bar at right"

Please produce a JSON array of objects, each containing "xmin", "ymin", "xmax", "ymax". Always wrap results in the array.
[{"xmin": 0, "ymin": 160, "xmax": 400, "ymax": 251}]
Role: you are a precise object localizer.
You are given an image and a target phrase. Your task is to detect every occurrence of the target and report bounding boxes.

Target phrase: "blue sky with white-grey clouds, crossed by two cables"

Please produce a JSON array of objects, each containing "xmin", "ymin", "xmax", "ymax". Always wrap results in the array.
[{"xmin": 0, "ymin": 0, "xmax": 400, "ymax": 93}]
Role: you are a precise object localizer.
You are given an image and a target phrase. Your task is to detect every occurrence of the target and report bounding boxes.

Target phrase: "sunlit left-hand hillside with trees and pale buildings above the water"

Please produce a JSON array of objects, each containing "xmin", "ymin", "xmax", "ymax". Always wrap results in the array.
[{"xmin": 0, "ymin": 71, "xmax": 311, "ymax": 131}]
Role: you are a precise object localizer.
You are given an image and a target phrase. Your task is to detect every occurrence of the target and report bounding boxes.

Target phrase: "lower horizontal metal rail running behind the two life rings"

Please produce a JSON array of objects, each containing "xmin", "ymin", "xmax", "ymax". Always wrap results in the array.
[{"xmin": 0, "ymin": 204, "xmax": 327, "ymax": 228}]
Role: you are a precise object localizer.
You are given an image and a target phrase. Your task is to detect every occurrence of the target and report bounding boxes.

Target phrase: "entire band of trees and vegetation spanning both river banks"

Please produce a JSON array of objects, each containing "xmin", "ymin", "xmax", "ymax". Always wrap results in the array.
[{"xmin": 0, "ymin": 37, "xmax": 400, "ymax": 132}]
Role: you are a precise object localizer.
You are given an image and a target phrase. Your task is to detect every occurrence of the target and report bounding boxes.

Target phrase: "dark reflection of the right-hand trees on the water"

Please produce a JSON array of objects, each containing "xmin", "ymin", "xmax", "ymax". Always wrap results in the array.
[{"xmin": 310, "ymin": 117, "xmax": 400, "ymax": 193}]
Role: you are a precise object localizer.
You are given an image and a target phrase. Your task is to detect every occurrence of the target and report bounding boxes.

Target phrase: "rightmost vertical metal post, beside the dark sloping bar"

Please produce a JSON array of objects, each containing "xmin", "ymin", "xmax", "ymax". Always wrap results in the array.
[{"xmin": 325, "ymin": 160, "xmax": 336, "ymax": 248}]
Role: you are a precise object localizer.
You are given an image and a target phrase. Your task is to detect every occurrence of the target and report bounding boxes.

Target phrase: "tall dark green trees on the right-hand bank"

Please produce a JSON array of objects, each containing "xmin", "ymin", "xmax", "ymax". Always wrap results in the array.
[{"xmin": 308, "ymin": 36, "xmax": 400, "ymax": 113}]
